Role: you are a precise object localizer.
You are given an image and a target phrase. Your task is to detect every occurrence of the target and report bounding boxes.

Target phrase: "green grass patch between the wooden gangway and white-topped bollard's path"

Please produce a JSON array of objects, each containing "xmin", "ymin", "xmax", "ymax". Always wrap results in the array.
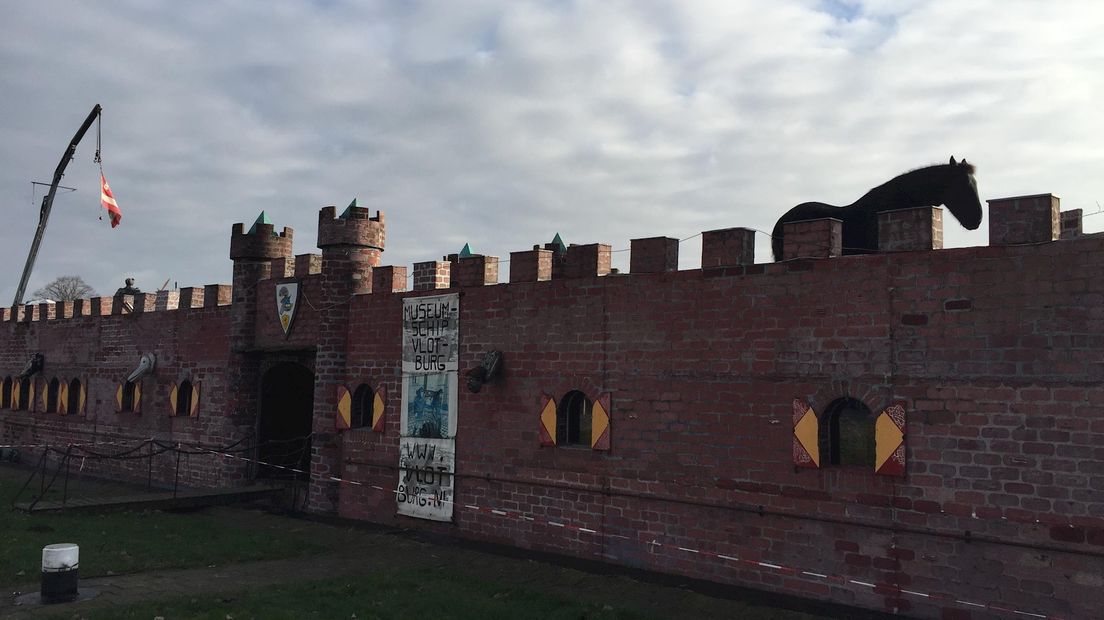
[{"xmin": 0, "ymin": 466, "xmax": 340, "ymax": 587}]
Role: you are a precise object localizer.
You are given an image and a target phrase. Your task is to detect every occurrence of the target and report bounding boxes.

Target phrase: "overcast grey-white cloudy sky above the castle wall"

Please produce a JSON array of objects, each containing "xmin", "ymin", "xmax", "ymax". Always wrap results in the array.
[{"xmin": 0, "ymin": 0, "xmax": 1104, "ymax": 304}]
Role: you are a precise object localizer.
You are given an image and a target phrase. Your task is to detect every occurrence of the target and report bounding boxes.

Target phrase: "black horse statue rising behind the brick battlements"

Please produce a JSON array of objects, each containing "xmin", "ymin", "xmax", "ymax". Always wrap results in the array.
[{"xmin": 771, "ymin": 156, "xmax": 981, "ymax": 260}]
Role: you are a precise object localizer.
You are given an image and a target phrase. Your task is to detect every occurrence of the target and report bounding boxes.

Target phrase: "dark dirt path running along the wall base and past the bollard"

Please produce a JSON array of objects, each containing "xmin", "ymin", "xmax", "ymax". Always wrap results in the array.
[{"xmin": 0, "ymin": 507, "xmax": 896, "ymax": 620}]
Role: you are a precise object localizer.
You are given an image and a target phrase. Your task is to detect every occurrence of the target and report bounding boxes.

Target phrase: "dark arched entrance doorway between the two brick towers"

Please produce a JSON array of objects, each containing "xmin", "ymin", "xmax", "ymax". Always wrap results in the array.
[{"xmin": 257, "ymin": 362, "xmax": 315, "ymax": 480}]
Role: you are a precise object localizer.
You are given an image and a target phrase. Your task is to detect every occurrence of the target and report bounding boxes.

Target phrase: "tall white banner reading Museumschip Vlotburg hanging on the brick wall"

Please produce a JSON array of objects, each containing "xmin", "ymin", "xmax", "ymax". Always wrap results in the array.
[{"xmin": 395, "ymin": 293, "xmax": 460, "ymax": 521}]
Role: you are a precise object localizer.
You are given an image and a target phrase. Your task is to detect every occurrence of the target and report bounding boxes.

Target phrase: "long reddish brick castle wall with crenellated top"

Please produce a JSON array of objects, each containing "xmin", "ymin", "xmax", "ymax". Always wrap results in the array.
[{"xmin": 0, "ymin": 194, "xmax": 1104, "ymax": 618}]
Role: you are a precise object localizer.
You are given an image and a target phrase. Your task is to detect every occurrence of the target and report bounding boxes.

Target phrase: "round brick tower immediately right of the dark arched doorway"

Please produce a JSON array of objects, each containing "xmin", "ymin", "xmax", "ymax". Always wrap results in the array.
[{"xmin": 309, "ymin": 201, "xmax": 384, "ymax": 513}]
